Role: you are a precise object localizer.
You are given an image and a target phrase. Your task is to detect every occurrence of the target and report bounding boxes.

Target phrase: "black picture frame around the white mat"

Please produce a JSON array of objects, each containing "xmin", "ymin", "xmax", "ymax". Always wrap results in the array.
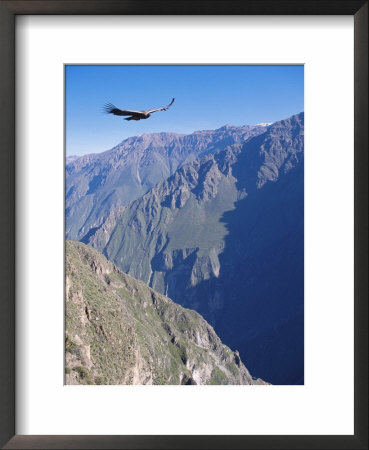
[{"xmin": 0, "ymin": 0, "xmax": 368, "ymax": 449}]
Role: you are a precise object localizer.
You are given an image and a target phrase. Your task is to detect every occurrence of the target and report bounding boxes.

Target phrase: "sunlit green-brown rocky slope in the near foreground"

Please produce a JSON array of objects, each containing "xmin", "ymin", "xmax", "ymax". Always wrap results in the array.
[{"xmin": 65, "ymin": 241, "xmax": 266, "ymax": 385}]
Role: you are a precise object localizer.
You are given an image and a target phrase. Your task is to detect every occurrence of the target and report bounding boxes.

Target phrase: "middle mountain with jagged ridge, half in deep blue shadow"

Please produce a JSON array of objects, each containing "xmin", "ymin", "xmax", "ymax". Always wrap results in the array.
[{"xmin": 84, "ymin": 113, "xmax": 304, "ymax": 384}]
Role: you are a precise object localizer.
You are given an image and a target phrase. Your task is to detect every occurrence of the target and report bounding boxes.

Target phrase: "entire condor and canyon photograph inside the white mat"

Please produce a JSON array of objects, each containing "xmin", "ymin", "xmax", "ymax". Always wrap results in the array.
[{"xmin": 63, "ymin": 64, "xmax": 305, "ymax": 389}]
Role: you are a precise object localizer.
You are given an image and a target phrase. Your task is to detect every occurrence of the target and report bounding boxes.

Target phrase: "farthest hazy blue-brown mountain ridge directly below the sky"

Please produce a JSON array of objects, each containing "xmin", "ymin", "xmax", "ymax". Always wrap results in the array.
[{"xmin": 66, "ymin": 125, "xmax": 265, "ymax": 240}]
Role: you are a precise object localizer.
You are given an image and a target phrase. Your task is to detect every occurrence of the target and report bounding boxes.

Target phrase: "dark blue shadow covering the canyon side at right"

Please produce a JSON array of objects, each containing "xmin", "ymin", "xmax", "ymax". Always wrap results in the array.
[{"xmin": 215, "ymin": 155, "xmax": 304, "ymax": 384}]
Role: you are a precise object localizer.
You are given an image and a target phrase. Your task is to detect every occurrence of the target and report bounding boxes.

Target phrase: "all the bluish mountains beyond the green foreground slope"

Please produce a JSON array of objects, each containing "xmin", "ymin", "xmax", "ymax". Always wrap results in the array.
[{"xmin": 66, "ymin": 113, "xmax": 304, "ymax": 384}]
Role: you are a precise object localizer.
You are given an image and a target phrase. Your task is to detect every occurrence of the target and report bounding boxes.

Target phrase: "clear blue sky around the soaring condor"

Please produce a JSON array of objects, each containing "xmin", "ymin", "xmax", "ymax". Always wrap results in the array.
[{"xmin": 65, "ymin": 65, "xmax": 304, "ymax": 155}]
